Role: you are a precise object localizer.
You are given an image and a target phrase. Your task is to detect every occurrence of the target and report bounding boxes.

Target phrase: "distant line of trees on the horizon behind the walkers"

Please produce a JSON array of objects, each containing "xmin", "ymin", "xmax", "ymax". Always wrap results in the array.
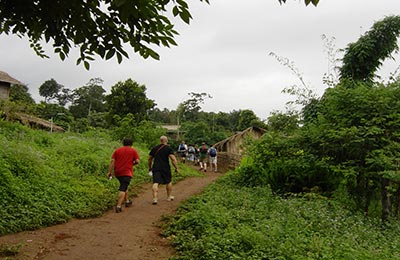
[{"xmin": 3, "ymin": 78, "xmax": 266, "ymax": 147}]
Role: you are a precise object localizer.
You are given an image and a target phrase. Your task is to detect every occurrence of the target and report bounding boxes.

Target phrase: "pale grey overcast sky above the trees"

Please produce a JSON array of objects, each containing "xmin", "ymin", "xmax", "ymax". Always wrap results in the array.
[{"xmin": 0, "ymin": 0, "xmax": 400, "ymax": 119}]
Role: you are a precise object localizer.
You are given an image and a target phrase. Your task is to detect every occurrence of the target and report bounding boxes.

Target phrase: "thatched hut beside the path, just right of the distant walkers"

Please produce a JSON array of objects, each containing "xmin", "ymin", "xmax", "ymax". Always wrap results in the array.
[{"xmin": 214, "ymin": 126, "xmax": 267, "ymax": 169}]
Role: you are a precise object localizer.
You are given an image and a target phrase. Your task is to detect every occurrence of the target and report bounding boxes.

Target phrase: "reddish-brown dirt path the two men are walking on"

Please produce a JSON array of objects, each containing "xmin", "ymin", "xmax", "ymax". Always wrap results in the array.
[{"xmin": 0, "ymin": 173, "xmax": 221, "ymax": 260}]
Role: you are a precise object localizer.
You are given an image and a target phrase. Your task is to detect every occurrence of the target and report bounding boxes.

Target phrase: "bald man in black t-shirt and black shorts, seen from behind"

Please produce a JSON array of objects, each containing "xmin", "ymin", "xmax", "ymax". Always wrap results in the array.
[{"xmin": 148, "ymin": 136, "xmax": 178, "ymax": 205}]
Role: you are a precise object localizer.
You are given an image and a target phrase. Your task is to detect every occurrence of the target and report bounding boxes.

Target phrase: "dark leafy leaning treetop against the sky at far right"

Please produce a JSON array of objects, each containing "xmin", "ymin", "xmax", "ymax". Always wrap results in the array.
[{"xmin": 340, "ymin": 16, "xmax": 400, "ymax": 82}]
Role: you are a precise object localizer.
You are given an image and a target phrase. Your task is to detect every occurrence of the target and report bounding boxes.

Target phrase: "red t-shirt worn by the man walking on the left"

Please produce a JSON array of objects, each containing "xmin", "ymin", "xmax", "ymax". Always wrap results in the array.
[{"xmin": 111, "ymin": 146, "xmax": 139, "ymax": 177}]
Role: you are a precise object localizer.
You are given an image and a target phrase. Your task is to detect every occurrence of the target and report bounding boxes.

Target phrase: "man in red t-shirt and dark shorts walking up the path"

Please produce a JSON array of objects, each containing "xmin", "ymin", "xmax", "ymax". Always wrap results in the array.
[{"xmin": 107, "ymin": 138, "xmax": 140, "ymax": 213}]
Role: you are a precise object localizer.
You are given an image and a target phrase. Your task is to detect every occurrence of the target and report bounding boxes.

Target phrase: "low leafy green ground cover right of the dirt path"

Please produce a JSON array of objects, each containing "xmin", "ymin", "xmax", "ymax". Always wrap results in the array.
[{"xmin": 163, "ymin": 173, "xmax": 400, "ymax": 260}]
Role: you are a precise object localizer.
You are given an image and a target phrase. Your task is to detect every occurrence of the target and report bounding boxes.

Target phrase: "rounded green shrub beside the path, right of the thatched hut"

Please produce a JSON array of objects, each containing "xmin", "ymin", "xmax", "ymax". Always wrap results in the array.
[{"xmin": 236, "ymin": 133, "xmax": 336, "ymax": 193}]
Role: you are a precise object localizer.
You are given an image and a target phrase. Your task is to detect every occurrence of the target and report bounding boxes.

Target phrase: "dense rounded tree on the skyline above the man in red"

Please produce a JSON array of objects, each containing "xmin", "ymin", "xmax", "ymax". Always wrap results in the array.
[{"xmin": 106, "ymin": 79, "xmax": 156, "ymax": 122}]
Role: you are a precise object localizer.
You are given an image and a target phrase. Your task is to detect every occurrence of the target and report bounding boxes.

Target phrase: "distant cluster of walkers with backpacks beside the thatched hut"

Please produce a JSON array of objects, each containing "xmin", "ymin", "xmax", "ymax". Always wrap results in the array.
[{"xmin": 177, "ymin": 141, "xmax": 218, "ymax": 172}]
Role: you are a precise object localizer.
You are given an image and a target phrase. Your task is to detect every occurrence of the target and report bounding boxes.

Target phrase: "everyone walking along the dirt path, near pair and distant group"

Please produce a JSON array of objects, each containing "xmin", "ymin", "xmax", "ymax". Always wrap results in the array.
[{"xmin": 107, "ymin": 136, "xmax": 217, "ymax": 213}]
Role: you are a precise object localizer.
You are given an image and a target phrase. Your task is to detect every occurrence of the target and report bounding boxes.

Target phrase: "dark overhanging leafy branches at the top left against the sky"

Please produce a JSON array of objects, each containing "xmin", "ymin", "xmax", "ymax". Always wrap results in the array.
[{"xmin": 0, "ymin": 0, "xmax": 318, "ymax": 69}]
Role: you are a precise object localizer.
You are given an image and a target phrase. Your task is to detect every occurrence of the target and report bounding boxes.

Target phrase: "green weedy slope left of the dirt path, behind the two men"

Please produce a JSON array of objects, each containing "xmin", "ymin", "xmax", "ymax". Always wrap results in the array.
[{"xmin": 0, "ymin": 121, "xmax": 200, "ymax": 235}]
